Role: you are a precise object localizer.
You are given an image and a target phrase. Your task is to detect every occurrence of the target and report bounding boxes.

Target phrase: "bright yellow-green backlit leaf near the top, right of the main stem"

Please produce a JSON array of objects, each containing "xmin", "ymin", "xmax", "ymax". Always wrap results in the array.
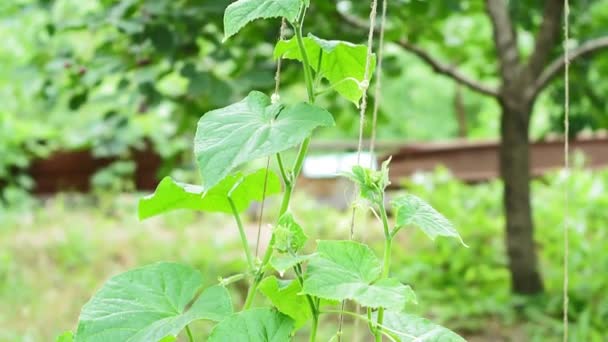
[{"xmin": 274, "ymin": 34, "xmax": 376, "ymax": 106}]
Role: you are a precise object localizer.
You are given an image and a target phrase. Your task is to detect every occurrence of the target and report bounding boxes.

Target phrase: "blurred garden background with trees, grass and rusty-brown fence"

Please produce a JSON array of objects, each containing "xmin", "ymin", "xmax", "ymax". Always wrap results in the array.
[{"xmin": 0, "ymin": 0, "xmax": 608, "ymax": 341}]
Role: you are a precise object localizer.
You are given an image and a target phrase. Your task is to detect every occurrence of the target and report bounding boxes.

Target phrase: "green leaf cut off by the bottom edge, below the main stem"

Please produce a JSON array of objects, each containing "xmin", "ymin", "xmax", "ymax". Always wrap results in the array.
[{"xmin": 208, "ymin": 308, "xmax": 294, "ymax": 342}]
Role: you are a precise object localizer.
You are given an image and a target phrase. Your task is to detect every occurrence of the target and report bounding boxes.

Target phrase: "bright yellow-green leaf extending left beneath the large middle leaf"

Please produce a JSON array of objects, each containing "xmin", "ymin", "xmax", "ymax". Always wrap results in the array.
[{"xmin": 138, "ymin": 169, "xmax": 281, "ymax": 220}]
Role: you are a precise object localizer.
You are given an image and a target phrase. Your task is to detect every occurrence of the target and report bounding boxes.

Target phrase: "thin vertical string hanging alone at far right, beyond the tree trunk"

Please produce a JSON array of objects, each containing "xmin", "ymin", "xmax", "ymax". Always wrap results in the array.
[{"xmin": 563, "ymin": 0, "xmax": 570, "ymax": 342}]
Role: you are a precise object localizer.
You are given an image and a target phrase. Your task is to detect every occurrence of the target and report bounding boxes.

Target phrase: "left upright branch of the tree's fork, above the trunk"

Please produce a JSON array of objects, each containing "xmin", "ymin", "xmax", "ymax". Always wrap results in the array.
[{"xmin": 486, "ymin": 0, "xmax": 520, "ymax": 85}]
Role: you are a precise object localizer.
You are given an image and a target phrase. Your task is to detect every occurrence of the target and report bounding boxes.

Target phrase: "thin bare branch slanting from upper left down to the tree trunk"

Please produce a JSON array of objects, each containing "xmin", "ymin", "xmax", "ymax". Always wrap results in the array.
[{"xmin": 397, "ymin": 39, "xmax": 498, "ymax": 97}]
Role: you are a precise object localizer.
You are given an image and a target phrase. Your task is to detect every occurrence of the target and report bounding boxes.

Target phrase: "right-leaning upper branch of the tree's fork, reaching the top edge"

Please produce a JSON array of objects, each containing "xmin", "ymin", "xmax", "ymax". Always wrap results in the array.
[{"xmin": 526, "ymin": 0, "xmax": 564, "ymax": 79}]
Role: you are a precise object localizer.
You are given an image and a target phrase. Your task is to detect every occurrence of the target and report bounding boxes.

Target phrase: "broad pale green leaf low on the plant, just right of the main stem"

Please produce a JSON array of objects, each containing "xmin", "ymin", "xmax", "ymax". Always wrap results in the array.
[{"xmin": 302, "ymin": 241, "xmax": 415, "ymax": 310}]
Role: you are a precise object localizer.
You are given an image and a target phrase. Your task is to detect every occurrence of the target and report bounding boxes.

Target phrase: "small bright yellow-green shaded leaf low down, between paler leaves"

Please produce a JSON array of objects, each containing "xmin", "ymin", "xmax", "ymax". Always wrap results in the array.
[{"xmin": 258, "ymin": 276, "xmax": 312, "ymax": 329}]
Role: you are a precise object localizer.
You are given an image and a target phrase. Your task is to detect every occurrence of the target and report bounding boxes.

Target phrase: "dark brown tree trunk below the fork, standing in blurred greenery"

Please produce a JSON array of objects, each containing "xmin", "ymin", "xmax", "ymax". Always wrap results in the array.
[{"xmin": 500, "ymin": 99, "xmax": 543, "ymax": 294}]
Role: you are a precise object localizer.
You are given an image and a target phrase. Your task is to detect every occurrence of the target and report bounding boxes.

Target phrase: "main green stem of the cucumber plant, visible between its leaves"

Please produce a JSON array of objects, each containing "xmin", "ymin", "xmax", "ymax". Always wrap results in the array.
[{"xmin": 243, "ymin": 5, "xmax": 315, "ymax": 310}]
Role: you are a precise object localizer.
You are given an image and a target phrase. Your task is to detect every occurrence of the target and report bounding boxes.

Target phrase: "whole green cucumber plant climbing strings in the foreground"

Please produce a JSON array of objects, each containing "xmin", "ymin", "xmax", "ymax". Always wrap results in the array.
[{"xmin": 65, "ymin": 0, "xmax": 464, "ymax": 342}]
